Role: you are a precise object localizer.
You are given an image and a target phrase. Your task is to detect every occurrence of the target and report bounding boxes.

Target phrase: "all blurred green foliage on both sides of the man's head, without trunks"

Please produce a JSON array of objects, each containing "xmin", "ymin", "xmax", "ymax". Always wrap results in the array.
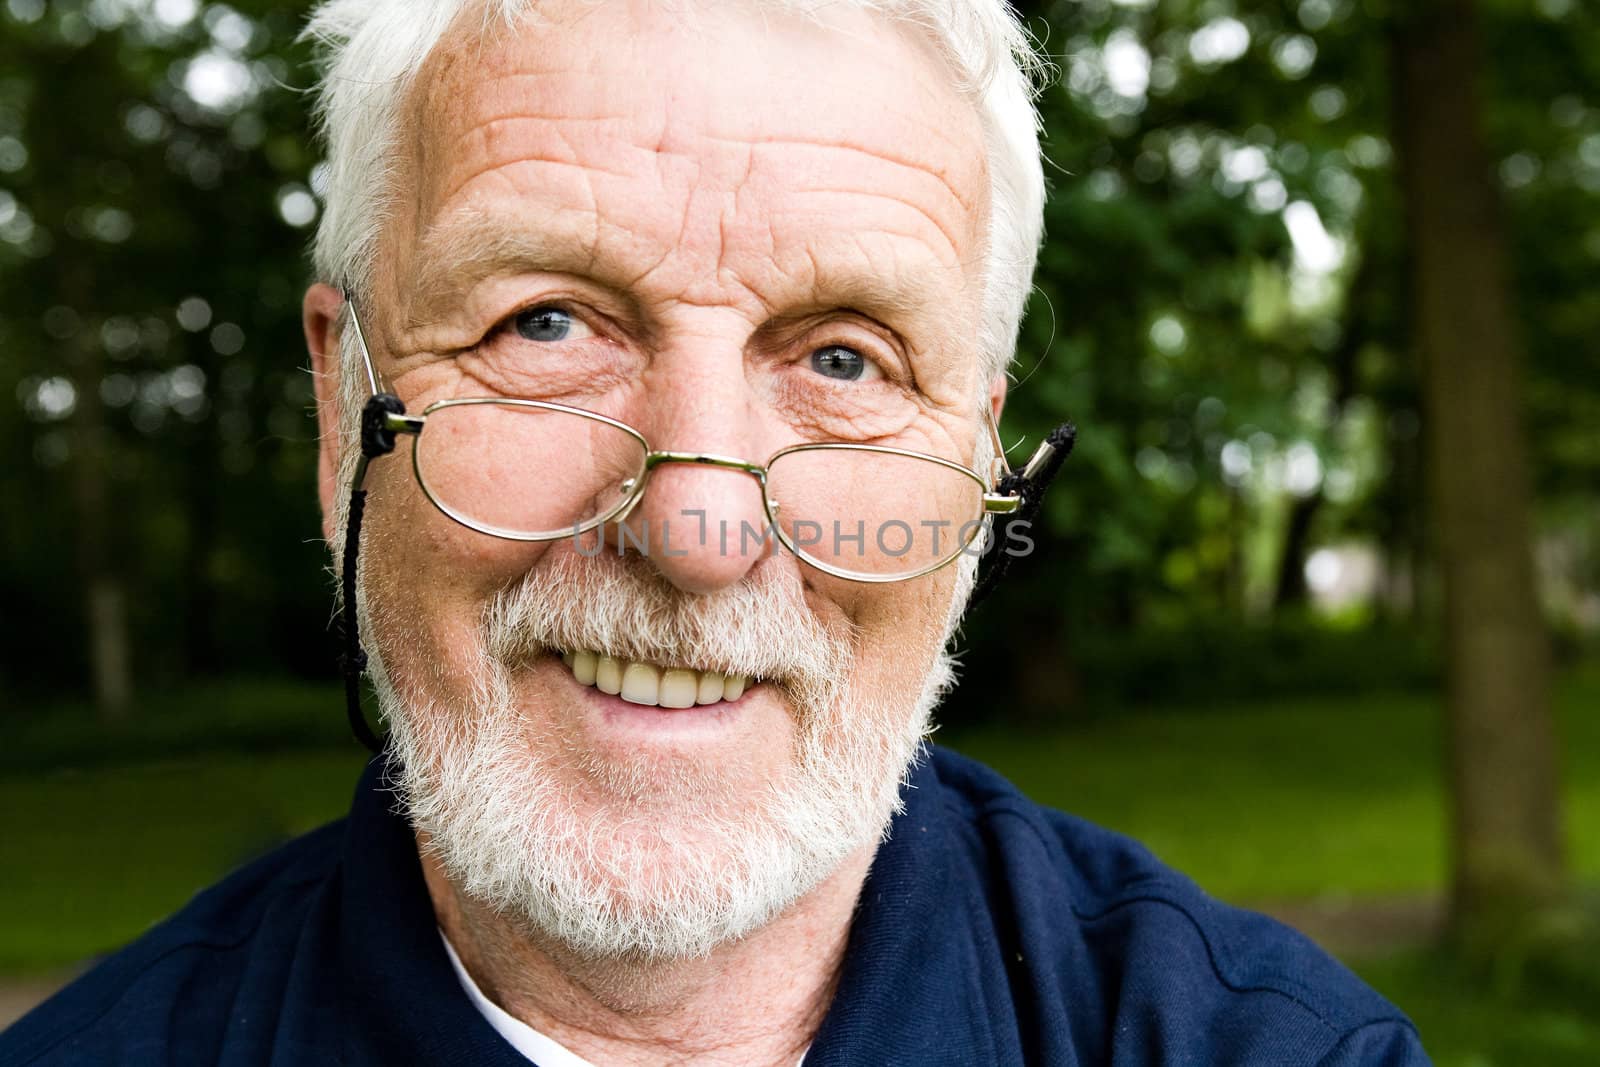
[{"xmin": 0, "ymin": 0, "xmax": 1600, "ymax": 703}]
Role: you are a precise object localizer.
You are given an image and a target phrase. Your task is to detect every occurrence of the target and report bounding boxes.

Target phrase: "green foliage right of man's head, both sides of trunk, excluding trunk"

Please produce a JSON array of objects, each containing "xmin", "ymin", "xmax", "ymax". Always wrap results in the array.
[{"xmin": 968, "ymin": 0, "xmax": 1600, "ymax": 721}]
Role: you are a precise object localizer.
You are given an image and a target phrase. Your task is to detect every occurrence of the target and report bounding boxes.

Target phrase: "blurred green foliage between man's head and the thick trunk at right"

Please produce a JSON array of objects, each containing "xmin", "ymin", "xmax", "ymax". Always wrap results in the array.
[{"xmin": 974, "ymin": 0, "xmax": 1421, "ymax": 709}]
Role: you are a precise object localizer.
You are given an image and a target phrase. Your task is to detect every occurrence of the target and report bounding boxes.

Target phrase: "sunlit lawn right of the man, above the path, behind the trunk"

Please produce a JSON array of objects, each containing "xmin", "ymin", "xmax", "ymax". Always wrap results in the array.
[{"xmin": 939, "ymin": 670, "xmax": 1600, "ymax": 901}]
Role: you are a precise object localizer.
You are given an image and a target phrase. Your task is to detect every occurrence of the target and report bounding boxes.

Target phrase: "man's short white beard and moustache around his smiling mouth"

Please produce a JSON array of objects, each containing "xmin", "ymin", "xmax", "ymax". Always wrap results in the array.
[{"xmin": 362, "ymin": 553, "xmax": 976, "ymax": 961}]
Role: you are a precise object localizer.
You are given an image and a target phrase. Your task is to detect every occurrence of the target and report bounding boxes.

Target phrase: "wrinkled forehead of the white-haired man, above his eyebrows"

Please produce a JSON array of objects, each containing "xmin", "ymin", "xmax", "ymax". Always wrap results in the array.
[{"xmin": 395, "ymin": 0, "xmax": 987, "ymax": 337}]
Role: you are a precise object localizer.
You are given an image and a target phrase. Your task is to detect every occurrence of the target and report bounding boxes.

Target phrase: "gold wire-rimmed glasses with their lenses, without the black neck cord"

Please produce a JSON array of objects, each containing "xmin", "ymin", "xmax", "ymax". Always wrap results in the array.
[{"xmin": 349, "ymin": 301, "xmax": 1021, "ymax": 582}]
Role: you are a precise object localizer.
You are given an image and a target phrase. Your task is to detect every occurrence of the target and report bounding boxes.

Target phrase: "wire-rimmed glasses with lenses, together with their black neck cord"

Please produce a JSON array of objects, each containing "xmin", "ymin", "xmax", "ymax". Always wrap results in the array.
[{"xmin": 339, "ymin": 291, "xmax": 1077, "ymax": 752}]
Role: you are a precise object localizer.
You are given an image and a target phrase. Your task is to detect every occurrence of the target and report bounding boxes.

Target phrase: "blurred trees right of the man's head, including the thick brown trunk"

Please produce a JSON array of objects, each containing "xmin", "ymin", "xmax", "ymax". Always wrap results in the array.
[{"xmin": 976, "ymin": 0, "xmax": 1600, "ymax": 966}]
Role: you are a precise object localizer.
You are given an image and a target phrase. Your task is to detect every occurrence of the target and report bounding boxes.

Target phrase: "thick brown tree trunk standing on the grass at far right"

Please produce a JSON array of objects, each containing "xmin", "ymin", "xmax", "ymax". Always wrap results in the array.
[{"xmin": 1392, "ymin": 0, "xmax": 1565, "ymax": 945}]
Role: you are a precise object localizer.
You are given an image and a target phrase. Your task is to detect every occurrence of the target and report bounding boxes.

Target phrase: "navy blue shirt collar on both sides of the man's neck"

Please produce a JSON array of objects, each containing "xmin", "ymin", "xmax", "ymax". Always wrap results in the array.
[{"xmin": 339, "ymin": 753, "xmax": 966, "ymax": 1067}]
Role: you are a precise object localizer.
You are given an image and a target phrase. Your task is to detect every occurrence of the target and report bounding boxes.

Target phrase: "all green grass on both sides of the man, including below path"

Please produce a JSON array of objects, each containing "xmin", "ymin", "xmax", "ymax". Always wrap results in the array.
[{"xmin": 0, "ymin": 669, "xmax": 1600, "ymax": 1067}]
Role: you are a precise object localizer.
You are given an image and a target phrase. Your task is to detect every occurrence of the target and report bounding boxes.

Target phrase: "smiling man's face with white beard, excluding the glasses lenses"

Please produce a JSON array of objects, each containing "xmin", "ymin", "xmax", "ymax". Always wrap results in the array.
[{"xmin": 308, "ymin": 3, "xmax": 987, "ymax": 953}]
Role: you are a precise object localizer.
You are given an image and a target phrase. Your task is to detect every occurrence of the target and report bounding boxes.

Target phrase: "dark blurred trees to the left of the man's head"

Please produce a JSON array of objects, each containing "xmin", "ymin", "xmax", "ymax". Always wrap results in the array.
[{"xmin": 0, "ymin": 0, "xmax": 328, "ymax": 709}]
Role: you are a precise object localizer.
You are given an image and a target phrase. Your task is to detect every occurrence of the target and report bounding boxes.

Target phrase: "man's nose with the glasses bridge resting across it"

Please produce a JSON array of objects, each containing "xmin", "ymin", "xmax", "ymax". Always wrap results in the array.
[{"xmin": 616, "ymin": 366, "xmax": 778, "ymax": 593}]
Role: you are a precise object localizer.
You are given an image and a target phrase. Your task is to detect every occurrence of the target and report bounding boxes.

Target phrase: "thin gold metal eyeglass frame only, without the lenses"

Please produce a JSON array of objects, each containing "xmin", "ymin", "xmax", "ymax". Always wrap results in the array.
[{"xmin": 344, "ymin": 290, "xmax": 1043, "ymax": 584}]
